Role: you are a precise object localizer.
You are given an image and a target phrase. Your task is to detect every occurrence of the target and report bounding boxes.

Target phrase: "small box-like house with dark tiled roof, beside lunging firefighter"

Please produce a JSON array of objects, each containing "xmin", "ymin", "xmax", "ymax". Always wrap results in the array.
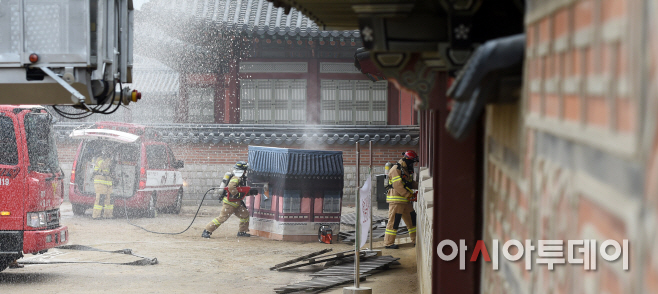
[{"xmin": 247, "ymin": 146, "xmax": 344, "ymax": 242}]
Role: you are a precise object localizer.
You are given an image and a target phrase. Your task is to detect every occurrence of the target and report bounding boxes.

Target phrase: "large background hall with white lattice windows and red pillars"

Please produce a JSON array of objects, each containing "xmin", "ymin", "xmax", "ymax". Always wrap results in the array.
[{"xmin": 135, "ymin": 0, "xmax": 416, "ymax": 126}]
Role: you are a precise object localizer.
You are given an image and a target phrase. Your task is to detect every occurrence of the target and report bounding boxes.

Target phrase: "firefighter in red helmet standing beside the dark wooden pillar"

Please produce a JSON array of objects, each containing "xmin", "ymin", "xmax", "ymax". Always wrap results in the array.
[{"xmin": 384, "ymin": 150, "xmax": 418, "ymax": 249}]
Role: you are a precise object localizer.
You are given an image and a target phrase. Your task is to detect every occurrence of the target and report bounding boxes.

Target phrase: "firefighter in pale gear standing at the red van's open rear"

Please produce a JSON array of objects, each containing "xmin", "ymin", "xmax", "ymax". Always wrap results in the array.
[{"xmin": 91, "ymin": 147, "xmax": 114, "ymax": 219}]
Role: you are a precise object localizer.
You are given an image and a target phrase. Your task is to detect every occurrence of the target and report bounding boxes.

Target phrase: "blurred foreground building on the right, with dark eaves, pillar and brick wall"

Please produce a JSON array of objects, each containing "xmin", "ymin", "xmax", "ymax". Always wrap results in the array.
[{"xmin": 264, "ymin": 0, "xmax": 658, "ymax": 293}]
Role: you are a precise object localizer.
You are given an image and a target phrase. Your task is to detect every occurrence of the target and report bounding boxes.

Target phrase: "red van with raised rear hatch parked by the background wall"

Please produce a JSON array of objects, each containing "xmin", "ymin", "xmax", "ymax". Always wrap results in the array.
[{"xmin": 69, "ymin": 122, "xmax": 184, "ymax": 217}]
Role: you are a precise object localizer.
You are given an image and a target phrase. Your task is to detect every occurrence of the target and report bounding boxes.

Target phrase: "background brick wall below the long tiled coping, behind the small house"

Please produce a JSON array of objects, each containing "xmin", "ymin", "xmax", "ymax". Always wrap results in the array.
[{"xmin": 57, "ymin": 142, "xmax": 416, "ymax": 205}]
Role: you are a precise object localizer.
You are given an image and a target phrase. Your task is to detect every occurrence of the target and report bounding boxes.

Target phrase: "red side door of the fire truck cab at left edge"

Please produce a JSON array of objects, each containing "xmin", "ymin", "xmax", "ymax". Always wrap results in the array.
[{"xmin": 0, "ymin": 111, "xmax": 26, "ymax": 231}]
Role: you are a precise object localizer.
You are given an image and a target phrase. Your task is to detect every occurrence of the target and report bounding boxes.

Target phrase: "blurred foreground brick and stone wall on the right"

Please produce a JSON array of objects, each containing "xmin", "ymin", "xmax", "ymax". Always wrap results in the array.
[{"xmin": 482, "ymin": 0, "xmax": 658, "ymax": 293}]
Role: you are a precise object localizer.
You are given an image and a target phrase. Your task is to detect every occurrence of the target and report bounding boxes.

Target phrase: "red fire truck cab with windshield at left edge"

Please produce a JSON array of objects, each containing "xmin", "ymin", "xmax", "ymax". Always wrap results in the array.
[{"xmin": 0, "ymin": 105, "xmax": 68, "ymax": 271}]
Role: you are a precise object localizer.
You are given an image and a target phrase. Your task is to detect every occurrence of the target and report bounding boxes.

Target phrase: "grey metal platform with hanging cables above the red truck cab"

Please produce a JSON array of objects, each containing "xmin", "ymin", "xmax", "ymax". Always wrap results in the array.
[{"xmin": 0, "ymin": 0, "xmax": 141, "ymax": 118}]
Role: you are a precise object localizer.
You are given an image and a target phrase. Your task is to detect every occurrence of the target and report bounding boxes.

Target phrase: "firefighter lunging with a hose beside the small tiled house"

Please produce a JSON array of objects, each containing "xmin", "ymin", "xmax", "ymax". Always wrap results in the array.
[{"xmin": 201, "ymin": 161, "xmax": 251, "ymax": 238}]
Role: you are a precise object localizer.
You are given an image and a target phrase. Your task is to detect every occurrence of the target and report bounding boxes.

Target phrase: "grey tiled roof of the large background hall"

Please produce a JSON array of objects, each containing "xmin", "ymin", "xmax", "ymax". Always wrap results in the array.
[{"xmin": 150, "ymin": 0, "xmax": 360, "ymax": 38}]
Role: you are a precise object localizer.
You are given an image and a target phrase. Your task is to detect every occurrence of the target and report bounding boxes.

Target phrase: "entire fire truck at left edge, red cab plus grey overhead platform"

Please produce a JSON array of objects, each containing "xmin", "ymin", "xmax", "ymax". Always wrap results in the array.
[{"xmin": 0, "ymin": 0, "xmax": 141, "ymax": 271}]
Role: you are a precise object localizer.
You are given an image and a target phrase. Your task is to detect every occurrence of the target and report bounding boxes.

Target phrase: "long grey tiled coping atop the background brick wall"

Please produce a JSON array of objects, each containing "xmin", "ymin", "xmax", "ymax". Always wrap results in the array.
[{"xmin": 54, "ymin": 123, "xmax": 420, "ymax": 146}]
